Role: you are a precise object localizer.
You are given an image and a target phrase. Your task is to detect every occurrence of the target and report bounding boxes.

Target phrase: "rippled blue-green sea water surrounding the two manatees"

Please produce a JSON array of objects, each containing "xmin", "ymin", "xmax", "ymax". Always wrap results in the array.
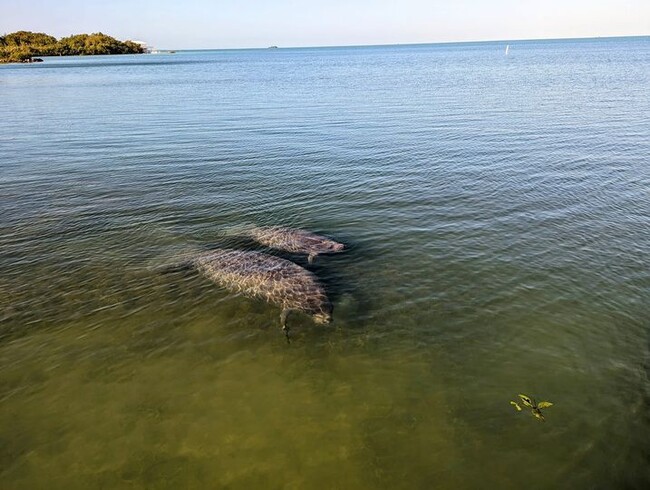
[{"xmin": 0, "ymin": 38, "xmax": 650, "ymax": 489}]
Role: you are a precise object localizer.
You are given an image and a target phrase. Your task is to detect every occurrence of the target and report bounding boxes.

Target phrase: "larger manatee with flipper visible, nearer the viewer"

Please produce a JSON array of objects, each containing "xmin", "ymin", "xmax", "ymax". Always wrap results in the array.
[{"xmin": 192, "ymin": 249, "xmax": 332, "ymax": 339}]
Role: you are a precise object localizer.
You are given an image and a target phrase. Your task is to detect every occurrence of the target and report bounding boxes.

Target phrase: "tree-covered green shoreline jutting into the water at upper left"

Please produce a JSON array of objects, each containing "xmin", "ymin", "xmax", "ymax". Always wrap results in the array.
[{"xmin": 0, "ymin": 31, "xmax": 146, "ymax": 63}]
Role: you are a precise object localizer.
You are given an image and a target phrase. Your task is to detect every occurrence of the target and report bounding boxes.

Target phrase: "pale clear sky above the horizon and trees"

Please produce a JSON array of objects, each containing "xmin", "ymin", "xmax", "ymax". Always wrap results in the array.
[{"xmin": 0, "ymin": 0, "xmax": 650, "ymax": 49}]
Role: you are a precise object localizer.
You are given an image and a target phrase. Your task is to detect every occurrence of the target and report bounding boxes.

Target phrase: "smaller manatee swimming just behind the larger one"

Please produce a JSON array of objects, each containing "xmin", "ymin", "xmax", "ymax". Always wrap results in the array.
[{"xmin": 248, "ymin": 226, "xmax": 344, "ymax": 264}]
